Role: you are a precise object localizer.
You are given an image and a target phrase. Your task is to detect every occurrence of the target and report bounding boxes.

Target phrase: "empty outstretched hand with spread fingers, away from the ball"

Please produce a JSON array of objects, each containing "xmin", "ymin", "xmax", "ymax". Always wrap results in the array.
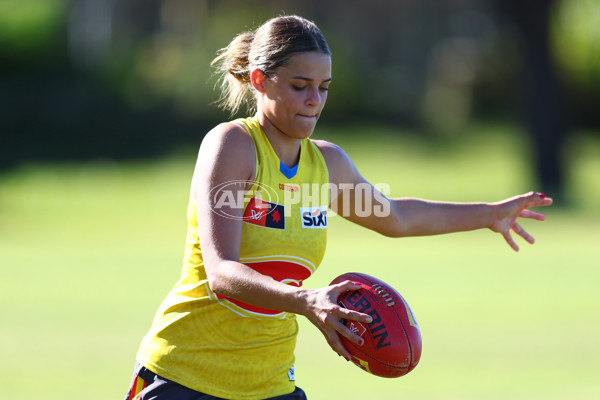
[{"xmin": 490, "ymin": 192, "xmax": 552, "ymax": 251}]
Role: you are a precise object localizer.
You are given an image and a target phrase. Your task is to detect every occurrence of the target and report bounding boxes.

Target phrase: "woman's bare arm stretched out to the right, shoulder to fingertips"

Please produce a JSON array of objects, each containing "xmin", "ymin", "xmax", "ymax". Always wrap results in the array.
[{"xmin": 315, "ymin": 141, "xmax": 552, "ymax": 251}]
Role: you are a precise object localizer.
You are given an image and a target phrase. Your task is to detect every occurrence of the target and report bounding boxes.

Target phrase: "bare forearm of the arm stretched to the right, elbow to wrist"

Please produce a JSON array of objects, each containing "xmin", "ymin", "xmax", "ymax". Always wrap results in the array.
[{"xmin": 389, "ymin": 198, "xmax": 496, "ymax": 236}]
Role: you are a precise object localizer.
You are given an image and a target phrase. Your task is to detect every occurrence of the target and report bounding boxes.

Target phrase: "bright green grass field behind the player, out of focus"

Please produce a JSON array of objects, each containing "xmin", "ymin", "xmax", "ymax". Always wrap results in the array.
[{"xmin": 0, "ymin": 123, "xmax": 600, "ymax": 400}]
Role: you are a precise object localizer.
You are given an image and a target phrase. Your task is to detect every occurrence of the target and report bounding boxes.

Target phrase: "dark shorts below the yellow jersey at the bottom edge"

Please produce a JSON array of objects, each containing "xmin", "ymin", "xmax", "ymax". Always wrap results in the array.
[{"xmin": 125, "ymin": 362, "xmax": 307, "ymax": 400}]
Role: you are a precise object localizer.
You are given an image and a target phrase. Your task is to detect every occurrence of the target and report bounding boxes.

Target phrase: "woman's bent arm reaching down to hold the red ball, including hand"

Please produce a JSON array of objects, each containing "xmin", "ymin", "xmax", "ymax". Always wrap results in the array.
[{"xmin": 192, "ymin": 122, "xmax": 371, "ymax": 359}]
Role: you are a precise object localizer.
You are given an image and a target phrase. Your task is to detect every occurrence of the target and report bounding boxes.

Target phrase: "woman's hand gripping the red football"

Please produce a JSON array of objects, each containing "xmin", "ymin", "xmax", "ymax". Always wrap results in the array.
[{"xmin": 302, "ymin": 281, "xmax": 372, "ymax": 361}]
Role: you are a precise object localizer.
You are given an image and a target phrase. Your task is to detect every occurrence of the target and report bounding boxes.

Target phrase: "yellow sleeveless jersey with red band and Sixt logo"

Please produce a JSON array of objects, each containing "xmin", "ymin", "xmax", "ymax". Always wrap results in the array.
[{"xmin": 137, "ymin": 117, "xmax": 329, "ymax": 399}]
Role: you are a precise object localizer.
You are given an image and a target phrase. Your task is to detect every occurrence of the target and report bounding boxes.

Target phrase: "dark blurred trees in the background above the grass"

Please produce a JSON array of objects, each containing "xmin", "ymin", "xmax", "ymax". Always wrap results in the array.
[{"xmin": 0, "ymin": 0, "xmax": 600, "ymax": 198}]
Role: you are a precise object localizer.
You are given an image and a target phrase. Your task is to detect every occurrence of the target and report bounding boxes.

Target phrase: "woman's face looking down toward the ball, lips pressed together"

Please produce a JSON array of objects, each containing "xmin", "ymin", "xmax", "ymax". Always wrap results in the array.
[{"xmin": 258, "ymin": 52, "xmax": 331, "ymax": 139}]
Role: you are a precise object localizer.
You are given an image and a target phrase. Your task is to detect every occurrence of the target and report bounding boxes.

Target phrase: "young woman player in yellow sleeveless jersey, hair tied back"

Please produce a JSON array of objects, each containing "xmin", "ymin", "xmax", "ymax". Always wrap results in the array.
[{"xmin": 127, "ymin": 16, "xmax": 552, "ymax": 400}]
